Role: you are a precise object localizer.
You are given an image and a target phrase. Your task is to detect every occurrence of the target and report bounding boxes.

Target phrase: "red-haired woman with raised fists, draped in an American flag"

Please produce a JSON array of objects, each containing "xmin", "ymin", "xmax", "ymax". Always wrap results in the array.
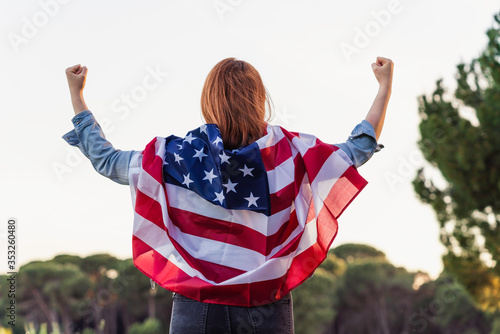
[{"xmin": 63, "ymin": 57, "xmax": 393, "ymax": 334}]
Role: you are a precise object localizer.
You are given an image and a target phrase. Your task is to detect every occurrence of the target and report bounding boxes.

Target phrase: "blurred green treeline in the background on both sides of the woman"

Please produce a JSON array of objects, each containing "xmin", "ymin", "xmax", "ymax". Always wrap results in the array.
[{"xmin": 8, "ymin": 244, "xmax": 499, "ymax": 334}]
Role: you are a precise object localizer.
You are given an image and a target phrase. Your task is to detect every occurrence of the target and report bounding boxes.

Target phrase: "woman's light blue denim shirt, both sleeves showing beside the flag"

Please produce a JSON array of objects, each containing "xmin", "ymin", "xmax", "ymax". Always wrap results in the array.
[{"xmin": 62, "ymin": 110, "xmax": 383, "ymax": 185}]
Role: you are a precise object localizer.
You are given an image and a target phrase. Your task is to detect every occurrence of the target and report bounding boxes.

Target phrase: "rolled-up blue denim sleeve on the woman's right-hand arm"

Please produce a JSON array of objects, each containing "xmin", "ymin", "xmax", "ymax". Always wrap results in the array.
[{"xmin": 335, "ymin": 120, "xmax": 384, "ymax": 168}]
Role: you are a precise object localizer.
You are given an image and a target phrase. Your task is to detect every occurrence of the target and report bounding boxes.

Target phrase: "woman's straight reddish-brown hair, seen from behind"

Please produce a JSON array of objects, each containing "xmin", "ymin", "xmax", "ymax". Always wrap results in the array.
[{"xmin": 201, "ymin": 58, "xmax": 271, "ymax": 149}]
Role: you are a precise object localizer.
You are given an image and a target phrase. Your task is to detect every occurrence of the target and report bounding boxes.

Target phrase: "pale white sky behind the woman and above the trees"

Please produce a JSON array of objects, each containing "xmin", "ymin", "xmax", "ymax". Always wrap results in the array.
[{"xmin": 0, "ymin": 0, "xmax": 500, "ymax": 277}]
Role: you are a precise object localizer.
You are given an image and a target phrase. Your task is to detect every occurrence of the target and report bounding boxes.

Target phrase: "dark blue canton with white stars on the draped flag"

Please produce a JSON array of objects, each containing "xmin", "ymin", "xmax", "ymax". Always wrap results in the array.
[{"xmin": 163, "ymin": 124, "xmax": 270, "ymax": 215}]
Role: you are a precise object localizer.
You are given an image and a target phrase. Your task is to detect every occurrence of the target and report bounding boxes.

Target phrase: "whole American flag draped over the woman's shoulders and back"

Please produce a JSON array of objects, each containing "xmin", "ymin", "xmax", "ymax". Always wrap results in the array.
[{"xmin": 129, "ymin": 124, "xmax": 367, "ymax": 306}]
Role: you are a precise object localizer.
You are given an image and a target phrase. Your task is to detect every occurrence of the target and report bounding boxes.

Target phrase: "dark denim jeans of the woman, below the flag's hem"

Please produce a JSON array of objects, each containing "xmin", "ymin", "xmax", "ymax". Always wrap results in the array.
[{"xmin": 170, "ymin": 293, "xmax": 294, "ymax": 334}]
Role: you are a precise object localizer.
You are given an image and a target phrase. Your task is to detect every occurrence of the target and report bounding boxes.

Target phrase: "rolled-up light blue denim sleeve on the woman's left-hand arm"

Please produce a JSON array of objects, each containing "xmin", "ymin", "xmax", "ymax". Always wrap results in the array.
[{"xmin": 62, "ymin": 110, "xmax": 135, "ymax": 185}]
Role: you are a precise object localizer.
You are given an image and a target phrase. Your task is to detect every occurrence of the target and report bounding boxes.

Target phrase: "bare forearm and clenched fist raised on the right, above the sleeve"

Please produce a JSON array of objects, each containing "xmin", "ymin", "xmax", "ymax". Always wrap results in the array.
[{"xmin": 365, "ymin": 57, "xmax": 394, "ymax": 140}]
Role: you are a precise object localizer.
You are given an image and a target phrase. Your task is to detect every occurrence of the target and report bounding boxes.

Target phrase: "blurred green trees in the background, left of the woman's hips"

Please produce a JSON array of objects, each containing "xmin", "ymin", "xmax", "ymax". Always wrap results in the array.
[{"xmin": 12, "ymin": 254, "xmax": 172, "ymax": 334}]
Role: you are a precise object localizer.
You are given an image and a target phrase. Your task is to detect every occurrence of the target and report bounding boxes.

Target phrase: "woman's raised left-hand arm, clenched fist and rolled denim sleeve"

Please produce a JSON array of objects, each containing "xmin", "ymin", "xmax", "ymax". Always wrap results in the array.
[{"xmin": 63, "ymin": 65, "xmax": 136, "ymax": 184}]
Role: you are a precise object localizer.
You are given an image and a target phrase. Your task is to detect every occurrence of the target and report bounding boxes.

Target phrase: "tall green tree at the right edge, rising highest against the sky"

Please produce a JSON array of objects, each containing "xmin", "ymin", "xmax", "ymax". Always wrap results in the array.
[{"xmin": 413, "ymin": 13, "xmax": 500, "ymax": 311}]
